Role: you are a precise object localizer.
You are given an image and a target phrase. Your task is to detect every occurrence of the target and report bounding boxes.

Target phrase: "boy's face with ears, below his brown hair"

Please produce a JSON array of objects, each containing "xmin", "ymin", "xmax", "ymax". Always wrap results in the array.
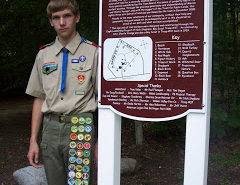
[{"xmin": 49, "ymin": 9, "xmax": 80, "ymax": 42}]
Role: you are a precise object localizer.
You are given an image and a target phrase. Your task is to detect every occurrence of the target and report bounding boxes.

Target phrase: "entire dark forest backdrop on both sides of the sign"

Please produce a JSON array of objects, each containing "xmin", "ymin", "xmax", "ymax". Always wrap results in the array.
[{"xmin": 0, "ymin": 0, "xmax": 240, "ymax": 138}]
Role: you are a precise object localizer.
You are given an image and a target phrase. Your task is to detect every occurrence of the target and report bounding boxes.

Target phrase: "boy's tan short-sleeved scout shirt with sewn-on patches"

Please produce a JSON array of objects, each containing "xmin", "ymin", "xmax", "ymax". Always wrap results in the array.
[{"xmin": 26, "ymin": 33, "xmax": 98, "ymax": 114}]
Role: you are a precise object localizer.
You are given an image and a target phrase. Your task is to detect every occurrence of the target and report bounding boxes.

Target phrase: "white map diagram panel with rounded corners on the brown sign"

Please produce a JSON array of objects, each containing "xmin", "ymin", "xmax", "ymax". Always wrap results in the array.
[{"xmin": 104, "ymin": 38, "xmax": 152, "ymax": 81}]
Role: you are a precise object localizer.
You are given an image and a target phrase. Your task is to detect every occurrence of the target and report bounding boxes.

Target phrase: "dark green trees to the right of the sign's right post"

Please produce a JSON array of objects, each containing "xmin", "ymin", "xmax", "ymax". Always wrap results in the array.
[{"xmin": 211, "ymin": 0, "xmax": 240, "ymax": 138}]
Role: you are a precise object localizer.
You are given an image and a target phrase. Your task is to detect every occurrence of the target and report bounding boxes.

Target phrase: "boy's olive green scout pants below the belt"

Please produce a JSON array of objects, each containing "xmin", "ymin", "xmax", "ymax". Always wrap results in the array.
[{"xmin": 41, "ymin": 113, "xmax": 94, "ymax": 185}]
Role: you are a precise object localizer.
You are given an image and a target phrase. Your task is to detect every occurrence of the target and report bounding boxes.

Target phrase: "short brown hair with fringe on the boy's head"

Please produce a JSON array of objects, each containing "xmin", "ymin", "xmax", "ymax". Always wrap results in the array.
[{"xmin": 47, "ymin": 0, "xmax": 79, "ymax": 18}]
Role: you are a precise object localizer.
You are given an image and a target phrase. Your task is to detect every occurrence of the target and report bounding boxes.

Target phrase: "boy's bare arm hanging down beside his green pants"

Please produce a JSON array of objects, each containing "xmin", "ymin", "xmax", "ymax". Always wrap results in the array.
[{"xmin": 27, "ymin": 98, "xmax": 44, "ymax": 168}]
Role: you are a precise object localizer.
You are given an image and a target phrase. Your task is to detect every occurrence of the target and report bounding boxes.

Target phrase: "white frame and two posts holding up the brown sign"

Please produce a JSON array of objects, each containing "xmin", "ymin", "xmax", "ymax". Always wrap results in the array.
[{"xmin": 98, "ymin": 0, "xmax": 213, "ymax": 185}]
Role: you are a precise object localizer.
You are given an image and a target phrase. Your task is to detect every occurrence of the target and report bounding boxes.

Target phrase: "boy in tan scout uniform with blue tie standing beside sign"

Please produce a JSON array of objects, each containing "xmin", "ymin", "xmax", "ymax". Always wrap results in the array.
[{"xmin": 26, "ymin": 0, "xmax": 98, "ymax": 185}]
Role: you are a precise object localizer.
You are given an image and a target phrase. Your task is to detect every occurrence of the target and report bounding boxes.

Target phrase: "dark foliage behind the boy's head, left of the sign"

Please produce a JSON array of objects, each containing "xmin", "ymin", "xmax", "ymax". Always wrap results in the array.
[{"xmin": 0, "ymin": 0, "xmax": 98, "ymax": 95}]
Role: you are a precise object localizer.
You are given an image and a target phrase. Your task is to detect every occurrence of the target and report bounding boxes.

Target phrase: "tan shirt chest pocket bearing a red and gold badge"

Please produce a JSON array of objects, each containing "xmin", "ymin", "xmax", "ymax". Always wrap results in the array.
[{"xmin": 72, "ymin": 66, "xmax": 92, "ymax": 90}]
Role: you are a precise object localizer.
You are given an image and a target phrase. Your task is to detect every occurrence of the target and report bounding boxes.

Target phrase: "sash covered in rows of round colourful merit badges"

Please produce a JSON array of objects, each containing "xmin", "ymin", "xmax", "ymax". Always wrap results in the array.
[{"xmin": 68, "ymin": 113, "xmax": 94, "ymax": 185}]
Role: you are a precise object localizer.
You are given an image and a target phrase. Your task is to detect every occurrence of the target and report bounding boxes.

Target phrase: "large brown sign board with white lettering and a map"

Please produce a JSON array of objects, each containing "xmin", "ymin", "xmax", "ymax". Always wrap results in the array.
[{"xmin": 100, "ymin": 0, "xmax": 204, "ymax": 119}]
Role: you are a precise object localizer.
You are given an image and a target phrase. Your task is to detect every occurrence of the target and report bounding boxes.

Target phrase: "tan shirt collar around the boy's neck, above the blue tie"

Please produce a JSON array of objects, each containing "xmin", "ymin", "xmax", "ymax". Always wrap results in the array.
[{"xmin": 55, "ymin": 33, "xmax": 81, "ymax": 55}]
